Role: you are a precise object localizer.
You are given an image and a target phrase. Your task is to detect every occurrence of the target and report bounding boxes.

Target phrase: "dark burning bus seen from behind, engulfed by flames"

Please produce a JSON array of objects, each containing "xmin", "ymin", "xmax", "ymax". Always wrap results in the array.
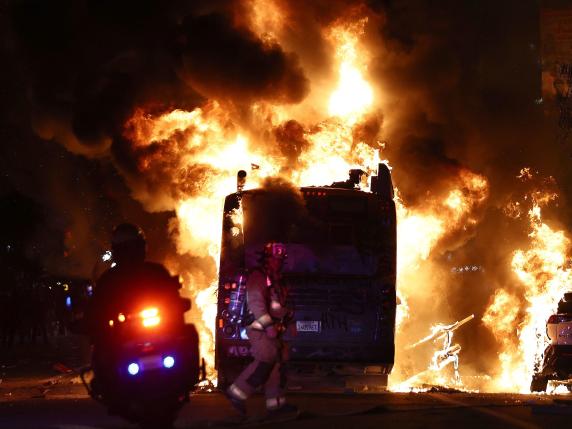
[{"xmin": 215, "ymin": 164, "xmax": 396, "ymax": 387}]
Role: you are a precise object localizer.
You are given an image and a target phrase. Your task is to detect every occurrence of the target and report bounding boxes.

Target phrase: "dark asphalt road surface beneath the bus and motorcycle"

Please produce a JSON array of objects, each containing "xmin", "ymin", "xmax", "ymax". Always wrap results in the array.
[{"xmin": 0, "ymin": 377, "xmax": 572, "ymax": 429}]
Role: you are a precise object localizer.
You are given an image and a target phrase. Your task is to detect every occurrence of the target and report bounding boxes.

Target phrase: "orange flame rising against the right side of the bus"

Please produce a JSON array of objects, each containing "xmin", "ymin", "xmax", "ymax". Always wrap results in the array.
[{"xmin": 390, "ymin": 169, "xmax": 488, "ymax": 391}]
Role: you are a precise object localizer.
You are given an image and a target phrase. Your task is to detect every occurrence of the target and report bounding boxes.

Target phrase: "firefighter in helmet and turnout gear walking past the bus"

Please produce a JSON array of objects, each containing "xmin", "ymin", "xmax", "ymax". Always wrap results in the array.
[{"xmin": 225, "ymin": 242, "xmax": 297, "ymax": 416}]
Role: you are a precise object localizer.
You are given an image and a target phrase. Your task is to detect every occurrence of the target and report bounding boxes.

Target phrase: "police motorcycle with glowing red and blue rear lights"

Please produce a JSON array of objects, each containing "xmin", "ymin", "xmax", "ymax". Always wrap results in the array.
[{"xmin": 81, "ymin": 294, "xmax": 199, "ymax": 428}]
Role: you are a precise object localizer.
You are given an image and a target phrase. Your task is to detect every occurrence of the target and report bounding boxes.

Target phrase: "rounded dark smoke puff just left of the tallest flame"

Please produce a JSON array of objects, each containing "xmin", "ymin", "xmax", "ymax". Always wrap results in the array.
[{"xmin": 179, "ymin": 13, "xmax": 309, "ymax": 104}]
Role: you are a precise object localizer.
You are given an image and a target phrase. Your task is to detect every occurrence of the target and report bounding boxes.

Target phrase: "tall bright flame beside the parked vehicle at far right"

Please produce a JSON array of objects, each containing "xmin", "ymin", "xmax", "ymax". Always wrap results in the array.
[{"xmin": 483, "ymin": 191, "xmax": 572, "ymax": 392}]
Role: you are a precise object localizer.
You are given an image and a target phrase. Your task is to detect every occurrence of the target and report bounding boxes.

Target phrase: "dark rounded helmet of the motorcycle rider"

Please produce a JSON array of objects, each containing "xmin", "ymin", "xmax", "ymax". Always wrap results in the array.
[{"xmin": 111, "ymin": 223, "xmax": 147, "ymax": 265}]
